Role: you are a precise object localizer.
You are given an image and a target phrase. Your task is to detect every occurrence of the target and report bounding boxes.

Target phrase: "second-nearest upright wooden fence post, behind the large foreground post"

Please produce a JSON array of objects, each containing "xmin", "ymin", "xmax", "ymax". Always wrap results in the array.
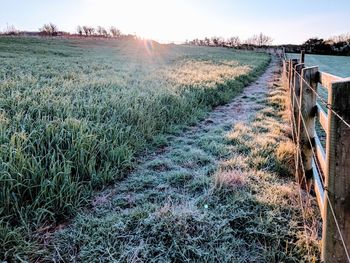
[{"xmin": 298, "ymin": 67, "xmax": 318, "ymax": 191}]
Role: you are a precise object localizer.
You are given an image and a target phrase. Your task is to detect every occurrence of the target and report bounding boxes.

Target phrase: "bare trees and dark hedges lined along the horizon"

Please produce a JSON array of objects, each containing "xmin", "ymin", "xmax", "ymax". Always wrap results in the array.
[{"xmin": 0, "ymin": 23, "xmax": 350, "ymax": 56}]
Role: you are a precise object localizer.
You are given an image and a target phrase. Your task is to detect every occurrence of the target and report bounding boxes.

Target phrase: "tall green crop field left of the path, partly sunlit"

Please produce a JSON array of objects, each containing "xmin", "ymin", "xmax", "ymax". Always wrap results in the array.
[{"xmin": 0, "ymin": 37, "xmax": 269, "ymax": 260}]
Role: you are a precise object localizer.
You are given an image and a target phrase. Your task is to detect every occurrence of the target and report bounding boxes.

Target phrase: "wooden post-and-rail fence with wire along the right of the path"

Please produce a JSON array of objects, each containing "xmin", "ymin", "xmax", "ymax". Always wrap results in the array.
[{"xmin": 282, "ymin": 52, "xmax": 350, "ymax": 263}]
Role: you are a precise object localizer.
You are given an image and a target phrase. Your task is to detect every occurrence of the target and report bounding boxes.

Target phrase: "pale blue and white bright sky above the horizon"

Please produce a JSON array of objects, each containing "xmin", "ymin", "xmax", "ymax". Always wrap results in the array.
[{"xmin": 0, "ymin": 0, "xmax": 350, "ymax": 44}]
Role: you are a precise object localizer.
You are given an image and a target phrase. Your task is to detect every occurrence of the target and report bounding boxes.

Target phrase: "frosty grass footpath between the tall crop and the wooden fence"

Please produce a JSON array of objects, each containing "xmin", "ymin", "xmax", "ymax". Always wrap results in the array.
[{"xmin": 48, "ymin": 58, "xmax": 318, "ymax": 262}]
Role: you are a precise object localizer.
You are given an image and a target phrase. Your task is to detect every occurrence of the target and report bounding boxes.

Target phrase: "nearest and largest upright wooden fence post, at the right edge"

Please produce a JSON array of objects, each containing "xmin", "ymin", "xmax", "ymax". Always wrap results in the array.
[{"xmin": 322, "ymin": 79, "xmax": 350, "ymax": 263}]
